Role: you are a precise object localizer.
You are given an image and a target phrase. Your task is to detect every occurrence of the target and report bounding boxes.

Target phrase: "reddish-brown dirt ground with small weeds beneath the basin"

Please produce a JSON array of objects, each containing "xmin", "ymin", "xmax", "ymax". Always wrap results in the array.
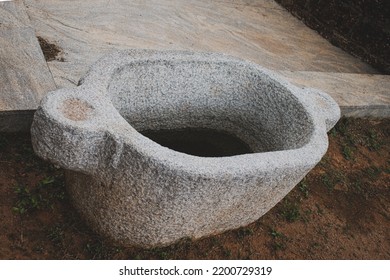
[{"xmin": 0, "ymin": 119, "xmax": 390, "ymax": 259}]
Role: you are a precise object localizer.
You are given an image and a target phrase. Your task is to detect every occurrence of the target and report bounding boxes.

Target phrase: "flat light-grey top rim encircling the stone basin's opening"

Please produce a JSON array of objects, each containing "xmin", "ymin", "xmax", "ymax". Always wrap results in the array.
[{"xmin": 33, "ymin": 50, "xmax": 339, "ymax": 176}]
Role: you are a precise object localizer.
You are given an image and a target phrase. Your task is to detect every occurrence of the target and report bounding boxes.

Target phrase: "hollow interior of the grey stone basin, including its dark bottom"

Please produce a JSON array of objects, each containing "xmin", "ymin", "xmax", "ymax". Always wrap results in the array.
[{"xmin": 107, "ymin": 60, "xmax": 314, "ymax": 157}]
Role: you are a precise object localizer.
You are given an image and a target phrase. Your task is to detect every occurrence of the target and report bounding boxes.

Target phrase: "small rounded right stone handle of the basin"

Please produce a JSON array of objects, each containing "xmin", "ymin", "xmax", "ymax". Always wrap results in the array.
[{"xmin": 303, "ymin": 88, "xmax": 340, "ymax": 131}]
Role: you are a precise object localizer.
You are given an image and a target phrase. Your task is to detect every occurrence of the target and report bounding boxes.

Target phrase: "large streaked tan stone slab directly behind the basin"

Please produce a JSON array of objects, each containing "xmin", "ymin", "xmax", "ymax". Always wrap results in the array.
[{"xmin": 25, "ymin": 0, "xmax": 376, "ymax": 87}]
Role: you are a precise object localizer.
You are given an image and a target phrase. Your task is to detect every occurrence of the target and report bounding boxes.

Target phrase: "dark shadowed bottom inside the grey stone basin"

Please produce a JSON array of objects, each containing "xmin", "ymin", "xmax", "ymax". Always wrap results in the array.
[{"xmin": 141, "ymin": 128, "xmax": 252, "ymax": 157}]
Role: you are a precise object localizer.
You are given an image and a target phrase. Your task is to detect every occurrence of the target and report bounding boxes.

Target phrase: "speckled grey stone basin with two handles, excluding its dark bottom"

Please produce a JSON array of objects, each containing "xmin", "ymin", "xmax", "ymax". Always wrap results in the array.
[{"xmin": 32, "ymin": 50, "xmax": 340, "ymax": 247}]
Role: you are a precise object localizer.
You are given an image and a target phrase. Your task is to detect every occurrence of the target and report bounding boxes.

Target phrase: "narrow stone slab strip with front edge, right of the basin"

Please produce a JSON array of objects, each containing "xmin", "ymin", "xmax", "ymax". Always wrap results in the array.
[{"xmin": 279, "ymin": 71, "xmax": 390, "ymax": 118}]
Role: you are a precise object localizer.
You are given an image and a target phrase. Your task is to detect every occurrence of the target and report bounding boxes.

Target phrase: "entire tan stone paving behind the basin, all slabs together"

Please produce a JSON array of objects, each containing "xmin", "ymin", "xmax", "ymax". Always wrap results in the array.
[{"xmin": 0, "ymin": 0, "xmax": 390, "ymax": 131}]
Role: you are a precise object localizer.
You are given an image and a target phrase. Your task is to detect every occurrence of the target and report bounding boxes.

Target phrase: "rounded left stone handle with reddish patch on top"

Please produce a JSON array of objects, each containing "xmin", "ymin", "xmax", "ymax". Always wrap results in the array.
[{"xmin": 31, "ymin": 89, "xmax": 105, "ymax": 173}]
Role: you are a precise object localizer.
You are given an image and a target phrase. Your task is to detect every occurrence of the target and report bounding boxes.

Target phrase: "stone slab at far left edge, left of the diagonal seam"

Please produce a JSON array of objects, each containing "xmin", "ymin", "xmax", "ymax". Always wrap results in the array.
[{"xmin": 0, "ymin": 1, "xmax": 56, "ymax": 131}]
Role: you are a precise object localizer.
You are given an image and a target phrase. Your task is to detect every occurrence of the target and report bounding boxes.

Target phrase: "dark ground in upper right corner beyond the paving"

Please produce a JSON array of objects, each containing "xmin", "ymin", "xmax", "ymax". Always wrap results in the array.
[{"xmin": 276, "ymin": 0, "xmax": 390, "ymax": 74}]
